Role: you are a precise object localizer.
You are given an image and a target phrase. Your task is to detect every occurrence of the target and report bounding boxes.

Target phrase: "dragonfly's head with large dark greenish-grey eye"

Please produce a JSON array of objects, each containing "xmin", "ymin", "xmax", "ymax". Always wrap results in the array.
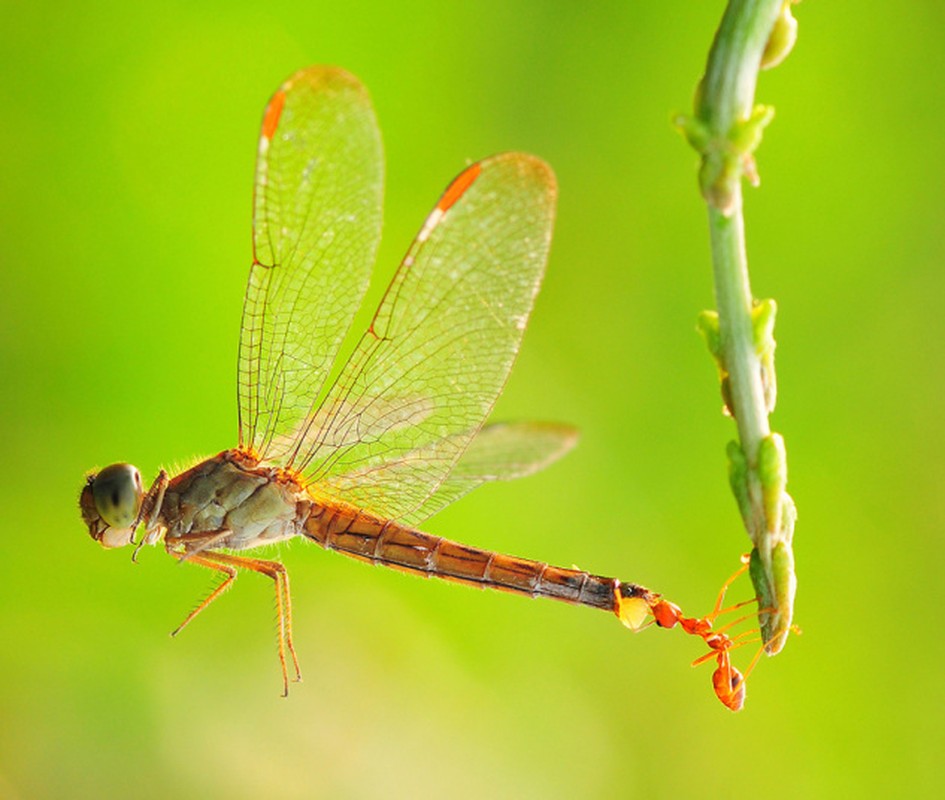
[{"xmin": 79, "ymin": 464, "xmax": 144, "ymax": 548}]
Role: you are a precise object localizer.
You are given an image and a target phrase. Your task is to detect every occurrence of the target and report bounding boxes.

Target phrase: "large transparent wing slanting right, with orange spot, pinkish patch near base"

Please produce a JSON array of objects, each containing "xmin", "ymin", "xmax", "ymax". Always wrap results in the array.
[{"xmin": 288, "ymin": 153, "xmax": 556, "ymax": 520}]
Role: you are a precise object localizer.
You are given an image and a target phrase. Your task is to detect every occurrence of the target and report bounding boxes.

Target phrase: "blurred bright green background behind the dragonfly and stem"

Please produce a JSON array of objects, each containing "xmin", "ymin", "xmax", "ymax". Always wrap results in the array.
[{"xmin": 0, "ymin": 0, "xmax": 945, "ymax": 798}]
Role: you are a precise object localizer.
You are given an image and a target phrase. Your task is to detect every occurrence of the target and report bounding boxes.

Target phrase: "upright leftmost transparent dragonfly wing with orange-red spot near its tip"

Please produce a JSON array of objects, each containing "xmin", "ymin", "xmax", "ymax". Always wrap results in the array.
[{"xmin": 238, "ymin": 67, "xmax": 383, "ymax": 463}]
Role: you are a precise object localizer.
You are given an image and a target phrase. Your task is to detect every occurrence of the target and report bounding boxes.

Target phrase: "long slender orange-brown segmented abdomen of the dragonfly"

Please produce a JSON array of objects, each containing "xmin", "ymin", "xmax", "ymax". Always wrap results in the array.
[{"xmin": 304, "ymin": 506, "xmax": 620, "ymax": 611}]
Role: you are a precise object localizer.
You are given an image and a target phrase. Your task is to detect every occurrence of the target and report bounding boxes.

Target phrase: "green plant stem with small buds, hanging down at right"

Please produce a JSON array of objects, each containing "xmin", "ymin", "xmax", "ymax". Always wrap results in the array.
[{"xmin": 685, "ymin": 0, "xmax": 796, "ymax": 655}]
